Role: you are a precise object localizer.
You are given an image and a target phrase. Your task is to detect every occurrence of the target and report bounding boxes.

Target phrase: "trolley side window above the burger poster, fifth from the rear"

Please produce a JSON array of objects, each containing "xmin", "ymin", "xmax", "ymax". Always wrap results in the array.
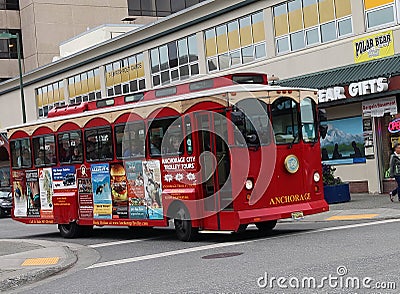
[{"xmin": 114, "ymin": 122, "xmax": 145, "ymax": 159}]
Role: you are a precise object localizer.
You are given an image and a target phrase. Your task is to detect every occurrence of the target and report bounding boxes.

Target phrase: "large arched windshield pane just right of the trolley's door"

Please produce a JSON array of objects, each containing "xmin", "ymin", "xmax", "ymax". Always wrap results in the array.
[{"xmin": 231, "ymin": 99, "xmax": 271, "ymax": 147}]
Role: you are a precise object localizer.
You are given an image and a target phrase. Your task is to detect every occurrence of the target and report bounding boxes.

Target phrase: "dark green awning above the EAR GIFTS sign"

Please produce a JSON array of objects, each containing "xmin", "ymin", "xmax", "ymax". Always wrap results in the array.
[{"xmin": 277, "ymin": 55, "xmax": 400, "ymax": 89}]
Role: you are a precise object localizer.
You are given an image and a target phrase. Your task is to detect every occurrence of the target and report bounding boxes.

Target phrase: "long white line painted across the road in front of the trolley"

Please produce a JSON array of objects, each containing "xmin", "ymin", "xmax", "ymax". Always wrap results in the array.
[{"xmin": 86, "ymin": 219, "xmax": 400, "ymax": 269}]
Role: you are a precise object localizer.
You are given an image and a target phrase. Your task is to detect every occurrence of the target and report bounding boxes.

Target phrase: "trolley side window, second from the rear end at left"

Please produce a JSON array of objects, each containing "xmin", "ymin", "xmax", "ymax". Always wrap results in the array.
[{"xmin": 32, "ymin": 135, "xmax": 57, "ymax": 167}]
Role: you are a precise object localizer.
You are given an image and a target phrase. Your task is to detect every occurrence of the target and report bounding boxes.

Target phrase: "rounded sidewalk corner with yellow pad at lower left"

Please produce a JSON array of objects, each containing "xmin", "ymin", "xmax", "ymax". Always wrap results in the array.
[{"xmin": 0, "ymin": 239, "xmax": 77, "ymax": 292}]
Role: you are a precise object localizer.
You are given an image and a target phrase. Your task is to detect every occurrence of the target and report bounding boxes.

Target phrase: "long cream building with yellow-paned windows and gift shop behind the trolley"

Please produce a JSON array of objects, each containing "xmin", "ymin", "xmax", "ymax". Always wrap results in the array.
[{"xmin": 0, "ymin": 0, "xmax": 400, "ymax": 192}]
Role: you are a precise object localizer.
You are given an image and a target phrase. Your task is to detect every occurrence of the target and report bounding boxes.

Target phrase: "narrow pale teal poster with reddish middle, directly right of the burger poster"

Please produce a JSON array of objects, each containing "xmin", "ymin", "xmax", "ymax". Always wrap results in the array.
[{"xmin": 125, "ymin": 160, "xmax": 147, "ymax": 219}]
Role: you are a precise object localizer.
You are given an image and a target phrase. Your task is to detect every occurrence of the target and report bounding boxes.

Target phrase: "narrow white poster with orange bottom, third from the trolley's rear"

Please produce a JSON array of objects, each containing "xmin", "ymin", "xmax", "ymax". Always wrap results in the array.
[{"xmin": 39, "ymin": 168, "xmax": 54, "ymax": 218}]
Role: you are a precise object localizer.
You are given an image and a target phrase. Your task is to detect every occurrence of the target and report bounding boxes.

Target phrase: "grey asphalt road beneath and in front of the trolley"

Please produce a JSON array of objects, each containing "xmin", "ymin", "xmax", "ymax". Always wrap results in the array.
[{"xmin": 0, "ymin": 219, "xmax": 400, "ymax": 293}]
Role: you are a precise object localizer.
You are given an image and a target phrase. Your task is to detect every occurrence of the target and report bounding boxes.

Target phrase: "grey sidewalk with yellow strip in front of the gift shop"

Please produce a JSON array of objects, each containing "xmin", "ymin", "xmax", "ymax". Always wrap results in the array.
[{"xmin": 302, "ymin": 194, "xmax": 400, "ymax": 222}]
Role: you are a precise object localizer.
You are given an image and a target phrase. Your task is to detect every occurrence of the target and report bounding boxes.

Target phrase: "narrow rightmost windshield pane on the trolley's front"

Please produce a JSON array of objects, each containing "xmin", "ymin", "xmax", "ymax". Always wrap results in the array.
[{"xmin": 300, "ymin": 98, "xmax": 317, "ymax": 143}]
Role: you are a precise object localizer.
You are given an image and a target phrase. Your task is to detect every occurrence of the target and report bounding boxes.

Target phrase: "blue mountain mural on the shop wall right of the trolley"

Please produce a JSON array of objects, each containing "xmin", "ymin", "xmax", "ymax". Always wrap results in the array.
[{"xmin": 321, "ymin": 116, "xmax": 366, "ymax": 165}]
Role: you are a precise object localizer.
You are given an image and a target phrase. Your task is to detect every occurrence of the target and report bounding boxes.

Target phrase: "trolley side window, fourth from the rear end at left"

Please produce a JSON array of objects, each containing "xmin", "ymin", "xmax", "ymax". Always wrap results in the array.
[{"xmin": 85, "ymin": 127, "xmax": 113, "ymax": 161}]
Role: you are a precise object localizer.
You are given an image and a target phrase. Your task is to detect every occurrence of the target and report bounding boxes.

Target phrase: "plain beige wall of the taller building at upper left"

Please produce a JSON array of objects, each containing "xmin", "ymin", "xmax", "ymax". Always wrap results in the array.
[{"xmin": 21, "ymin": 0, "xmax": 128, "ymax": 71}]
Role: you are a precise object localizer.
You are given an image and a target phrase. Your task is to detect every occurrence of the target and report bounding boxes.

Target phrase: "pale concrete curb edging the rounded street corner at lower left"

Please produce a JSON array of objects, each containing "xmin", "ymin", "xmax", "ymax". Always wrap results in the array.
[{"xmin": 0, "ymin": 246, "xmax": 78, "ymax": 292}]
